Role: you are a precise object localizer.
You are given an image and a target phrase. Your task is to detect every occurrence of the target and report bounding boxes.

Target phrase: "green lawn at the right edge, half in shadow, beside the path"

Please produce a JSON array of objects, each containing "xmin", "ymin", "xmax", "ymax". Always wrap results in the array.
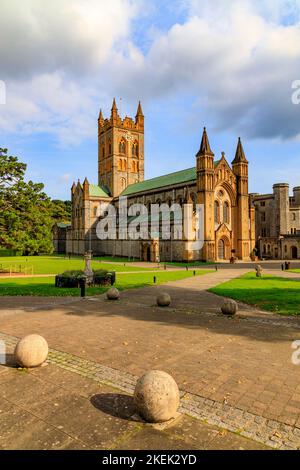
[{"xmin": 210, "ymin": 273, "xmax": 300, "ymax": 315}]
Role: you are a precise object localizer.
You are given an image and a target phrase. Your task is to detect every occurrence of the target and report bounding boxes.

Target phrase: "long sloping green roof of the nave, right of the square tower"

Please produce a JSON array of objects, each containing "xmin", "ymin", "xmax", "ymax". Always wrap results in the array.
[{"xmin": 121, "ymin": 160, "xmax": 220, "ymax": 196}]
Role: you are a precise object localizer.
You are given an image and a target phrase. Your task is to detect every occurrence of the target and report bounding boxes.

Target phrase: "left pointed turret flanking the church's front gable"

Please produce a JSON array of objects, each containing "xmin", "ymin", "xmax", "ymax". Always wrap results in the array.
[{"xmin": 196, "ymin": 128, "xmax": 215, "ymax": 261}]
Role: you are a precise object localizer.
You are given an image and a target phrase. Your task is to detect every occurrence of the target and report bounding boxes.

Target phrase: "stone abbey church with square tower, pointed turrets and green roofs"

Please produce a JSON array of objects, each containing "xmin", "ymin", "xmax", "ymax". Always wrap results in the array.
[{"xmin": 66, "ymin": 100, "xmax": 255, "ymax": 262}]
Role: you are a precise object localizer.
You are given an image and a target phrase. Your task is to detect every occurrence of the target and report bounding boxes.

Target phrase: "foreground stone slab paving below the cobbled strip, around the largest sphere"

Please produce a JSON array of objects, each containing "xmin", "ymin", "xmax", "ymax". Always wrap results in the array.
[{"xmin": 0, "ymin": 364, "xmax": 268, "ymax": 450}]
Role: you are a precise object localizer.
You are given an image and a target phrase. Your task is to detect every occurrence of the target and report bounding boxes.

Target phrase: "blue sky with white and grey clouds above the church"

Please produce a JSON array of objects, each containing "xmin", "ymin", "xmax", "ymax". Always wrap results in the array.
[{"xmin": 0, "ymin": 0, "xmax": 300, "ymax": 199}]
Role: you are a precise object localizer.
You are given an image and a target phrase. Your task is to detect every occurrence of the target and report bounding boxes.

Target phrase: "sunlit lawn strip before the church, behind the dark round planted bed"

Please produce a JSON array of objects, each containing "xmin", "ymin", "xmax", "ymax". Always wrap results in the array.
[{"xmin": 0, "ymin": 256, "xmax": 153, "ymax": 274}]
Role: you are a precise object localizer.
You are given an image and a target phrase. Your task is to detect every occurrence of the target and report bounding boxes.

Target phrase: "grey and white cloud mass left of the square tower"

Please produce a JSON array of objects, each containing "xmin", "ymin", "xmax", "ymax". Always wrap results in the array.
[{"xmin": 0, "ymin": 0, "xmax": 140, "ymax": 145}]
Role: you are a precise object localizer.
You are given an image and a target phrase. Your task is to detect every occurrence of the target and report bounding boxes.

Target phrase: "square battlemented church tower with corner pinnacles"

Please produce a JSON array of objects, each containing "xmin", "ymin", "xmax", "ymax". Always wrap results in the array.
[{"xmin": 98, "ymin": 99, "xmax": 144, "ymax": 197}]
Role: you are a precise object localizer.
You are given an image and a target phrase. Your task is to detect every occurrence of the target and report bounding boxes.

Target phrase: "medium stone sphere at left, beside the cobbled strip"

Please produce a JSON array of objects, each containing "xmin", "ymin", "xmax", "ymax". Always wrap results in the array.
[{"xmin": 15, "ymin": 335, "xmax": 48, "ymax": 368}]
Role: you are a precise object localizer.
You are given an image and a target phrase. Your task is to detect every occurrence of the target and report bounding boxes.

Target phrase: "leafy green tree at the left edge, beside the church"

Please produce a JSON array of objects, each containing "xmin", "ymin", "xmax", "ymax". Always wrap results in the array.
[{"xmin": 0, "ymin": 148, "xmax": 53, "ymax": 254}]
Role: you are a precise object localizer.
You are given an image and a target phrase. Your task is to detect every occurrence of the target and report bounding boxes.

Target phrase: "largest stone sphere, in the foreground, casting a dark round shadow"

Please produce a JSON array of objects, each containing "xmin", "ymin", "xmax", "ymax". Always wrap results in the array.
[{"xmin": 134, "ymin": 370, "xmax": 180, "ymax": 423}]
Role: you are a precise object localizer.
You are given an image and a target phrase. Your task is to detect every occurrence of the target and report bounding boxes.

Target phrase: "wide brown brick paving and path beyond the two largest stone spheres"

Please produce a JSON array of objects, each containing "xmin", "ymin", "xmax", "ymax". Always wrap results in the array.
[{"xmin": 0, "ymin": 268, "xmax": 300, "ymax": 449}]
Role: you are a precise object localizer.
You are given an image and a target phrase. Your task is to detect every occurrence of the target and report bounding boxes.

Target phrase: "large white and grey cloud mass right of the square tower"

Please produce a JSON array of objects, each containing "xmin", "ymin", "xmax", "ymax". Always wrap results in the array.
[{"xmin": 111, "ymin": 0, "xmax": 300, "ymax": 138}]
